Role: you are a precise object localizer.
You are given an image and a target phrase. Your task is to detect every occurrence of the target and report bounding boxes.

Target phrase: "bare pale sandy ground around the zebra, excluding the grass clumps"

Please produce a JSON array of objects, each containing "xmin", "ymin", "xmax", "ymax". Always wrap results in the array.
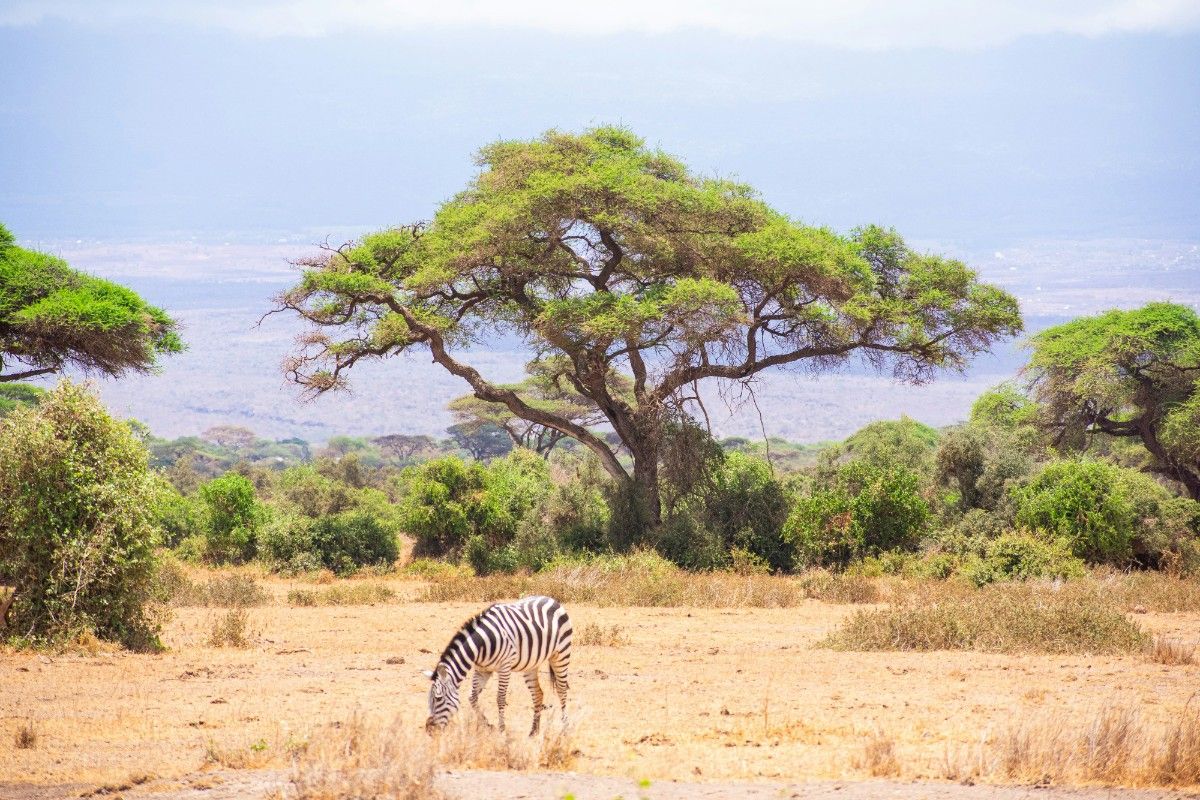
[{"xmin": 0, "ymin": 582, "xmax": 1200, "ymax": 798}]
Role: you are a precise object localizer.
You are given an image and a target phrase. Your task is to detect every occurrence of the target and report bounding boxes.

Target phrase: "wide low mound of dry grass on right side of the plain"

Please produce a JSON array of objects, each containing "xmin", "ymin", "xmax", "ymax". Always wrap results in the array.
[{"xmin": 823, "ymin": 582, "xmax": 1148, "ymax": 654}]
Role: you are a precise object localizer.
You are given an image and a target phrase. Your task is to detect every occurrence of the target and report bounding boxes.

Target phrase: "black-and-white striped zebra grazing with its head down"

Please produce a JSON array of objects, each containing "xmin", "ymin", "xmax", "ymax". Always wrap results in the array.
[{"xmin": 425, "ymin": 597, "xmax": 571, "ymax": 736}]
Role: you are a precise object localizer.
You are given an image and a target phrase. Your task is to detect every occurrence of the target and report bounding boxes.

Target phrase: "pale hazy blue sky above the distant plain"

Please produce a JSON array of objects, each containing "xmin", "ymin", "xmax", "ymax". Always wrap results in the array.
[{"xmin": 0, "ymin": 0, "xmax": 1200, "ymax": 246}]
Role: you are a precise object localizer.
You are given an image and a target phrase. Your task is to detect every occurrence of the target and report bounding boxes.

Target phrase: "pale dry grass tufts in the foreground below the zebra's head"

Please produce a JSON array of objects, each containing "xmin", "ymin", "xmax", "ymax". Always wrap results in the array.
[{"xmin": 280, "ymin": 711, "xmax": 578, "ymax": 800}]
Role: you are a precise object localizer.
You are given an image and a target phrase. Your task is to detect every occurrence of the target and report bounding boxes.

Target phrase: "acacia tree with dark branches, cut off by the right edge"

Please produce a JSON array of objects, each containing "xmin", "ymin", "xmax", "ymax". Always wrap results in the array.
[{"xmin": 1027, "ymin": 302, "xmax": 1200, "ymax": 500}]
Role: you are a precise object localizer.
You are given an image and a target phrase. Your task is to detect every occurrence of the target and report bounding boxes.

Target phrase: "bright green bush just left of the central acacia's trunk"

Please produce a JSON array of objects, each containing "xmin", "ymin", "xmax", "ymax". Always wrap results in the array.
[{"xmin": 400, "ymin": 450, "xmax": 551, "ymax": 567}]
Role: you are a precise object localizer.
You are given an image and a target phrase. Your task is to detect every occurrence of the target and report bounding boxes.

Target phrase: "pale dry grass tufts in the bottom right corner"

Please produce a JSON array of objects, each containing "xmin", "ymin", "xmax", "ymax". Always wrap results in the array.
[{"xmin": 995, "ymin": 704, "xmax": 1200, "ymax": 787}]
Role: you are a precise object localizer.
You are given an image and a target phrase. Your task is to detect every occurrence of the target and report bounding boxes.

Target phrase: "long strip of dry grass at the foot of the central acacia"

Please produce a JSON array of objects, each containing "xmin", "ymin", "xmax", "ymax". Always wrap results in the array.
[{"xmin": 420, "ymin": 557, "xmax": 880, "ymax": 608}]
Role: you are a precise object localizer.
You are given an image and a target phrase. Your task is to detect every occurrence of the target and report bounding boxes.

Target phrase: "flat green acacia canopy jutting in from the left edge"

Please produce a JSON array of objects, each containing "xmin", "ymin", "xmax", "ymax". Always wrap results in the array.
[{"xmin": 0, "ymin": 220, "xmax": 184, "ymax": 383}]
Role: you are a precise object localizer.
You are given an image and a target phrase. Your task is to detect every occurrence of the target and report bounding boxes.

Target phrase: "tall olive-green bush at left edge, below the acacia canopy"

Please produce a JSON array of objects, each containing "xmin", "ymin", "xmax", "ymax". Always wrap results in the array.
[{"xmin": 0, "ymin": 380, "xmax": 160, "ymax": 648}]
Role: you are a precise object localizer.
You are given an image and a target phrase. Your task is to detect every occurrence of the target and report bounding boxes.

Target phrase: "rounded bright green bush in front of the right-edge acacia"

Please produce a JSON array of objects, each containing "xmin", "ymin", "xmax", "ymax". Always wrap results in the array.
[{"xmin": 1014, "ymin": 458, "xmax": 1136, "ymax": 565}]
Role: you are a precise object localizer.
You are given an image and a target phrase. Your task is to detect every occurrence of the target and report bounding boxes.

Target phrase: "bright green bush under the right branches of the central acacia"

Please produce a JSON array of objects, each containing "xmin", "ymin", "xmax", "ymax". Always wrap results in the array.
[{"xmin": 784, "ymin": 461, "xmax": 929, "ymax": 569}]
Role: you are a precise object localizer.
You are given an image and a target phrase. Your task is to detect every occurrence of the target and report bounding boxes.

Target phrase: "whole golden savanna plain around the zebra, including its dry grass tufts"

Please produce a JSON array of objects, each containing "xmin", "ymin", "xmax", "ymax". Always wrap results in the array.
[{"xmin": 0, "ymin": 570, "xmax": 1200, "ymax": 798}]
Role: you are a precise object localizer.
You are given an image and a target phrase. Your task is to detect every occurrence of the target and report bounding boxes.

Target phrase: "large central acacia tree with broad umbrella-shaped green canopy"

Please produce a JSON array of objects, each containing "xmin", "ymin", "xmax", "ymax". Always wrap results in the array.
[{"xmin": 278, "ymin": 127, "xmax": 1021, "ymax": 525}]
